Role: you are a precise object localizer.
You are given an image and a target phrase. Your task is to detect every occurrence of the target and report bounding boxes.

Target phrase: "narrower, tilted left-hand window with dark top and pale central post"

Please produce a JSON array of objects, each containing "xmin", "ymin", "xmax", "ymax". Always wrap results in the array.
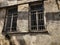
[{"xmin": 4, "ymin": 7, "xmax": 17, "ymax": 32}]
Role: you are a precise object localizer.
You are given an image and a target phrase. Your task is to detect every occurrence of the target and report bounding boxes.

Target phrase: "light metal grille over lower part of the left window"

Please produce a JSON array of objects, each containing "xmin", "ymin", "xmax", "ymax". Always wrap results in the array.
[{"xmin": 4, "ymin": 14, "xmax": 17, "ymax": 32}]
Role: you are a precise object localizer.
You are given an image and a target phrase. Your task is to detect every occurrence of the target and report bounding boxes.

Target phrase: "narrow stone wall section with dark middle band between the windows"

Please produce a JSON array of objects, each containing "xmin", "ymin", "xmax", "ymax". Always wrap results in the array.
[{"xmin": 17, "ymin": 4, "xmax": 29, "ymax": 32}]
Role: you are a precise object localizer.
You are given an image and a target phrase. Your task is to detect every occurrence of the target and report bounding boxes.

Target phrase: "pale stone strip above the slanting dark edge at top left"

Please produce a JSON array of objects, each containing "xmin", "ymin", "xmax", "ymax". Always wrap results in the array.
[{"xmin": 0, "ymin": 0, "xmax": 38, "ymax": 7}]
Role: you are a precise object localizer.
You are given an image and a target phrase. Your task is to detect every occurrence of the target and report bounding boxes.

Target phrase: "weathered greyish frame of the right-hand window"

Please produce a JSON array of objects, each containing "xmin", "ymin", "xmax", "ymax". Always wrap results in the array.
[{"xmin": 29, "ymin": 2, "xmax": 46, "ymax": 32}]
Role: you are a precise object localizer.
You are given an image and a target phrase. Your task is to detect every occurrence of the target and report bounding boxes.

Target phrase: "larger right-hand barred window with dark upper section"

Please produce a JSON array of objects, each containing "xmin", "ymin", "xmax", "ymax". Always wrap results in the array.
[{"xmin": 29, "ymin": 1, "xmax": 45, "ymax": 31}]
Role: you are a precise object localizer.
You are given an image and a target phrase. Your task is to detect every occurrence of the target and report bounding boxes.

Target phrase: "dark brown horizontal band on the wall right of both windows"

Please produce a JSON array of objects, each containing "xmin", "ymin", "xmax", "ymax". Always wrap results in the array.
[{"xmin": 46, "ymin": 12, "xmax": 60, "ymax": 21}]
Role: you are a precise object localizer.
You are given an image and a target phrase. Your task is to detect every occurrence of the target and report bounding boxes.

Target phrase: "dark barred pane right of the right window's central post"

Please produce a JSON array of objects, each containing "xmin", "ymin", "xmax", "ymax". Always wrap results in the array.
[{"xmin": 38, "ymin": 13, "xmax": 45, "ymax": 30}]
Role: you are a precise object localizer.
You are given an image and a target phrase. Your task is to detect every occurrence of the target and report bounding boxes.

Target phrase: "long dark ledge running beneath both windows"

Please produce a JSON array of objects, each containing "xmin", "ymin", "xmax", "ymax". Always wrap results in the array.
[{"xmin": 4, "ymin": 31, "xmax": 49, "ymax": 35}]
